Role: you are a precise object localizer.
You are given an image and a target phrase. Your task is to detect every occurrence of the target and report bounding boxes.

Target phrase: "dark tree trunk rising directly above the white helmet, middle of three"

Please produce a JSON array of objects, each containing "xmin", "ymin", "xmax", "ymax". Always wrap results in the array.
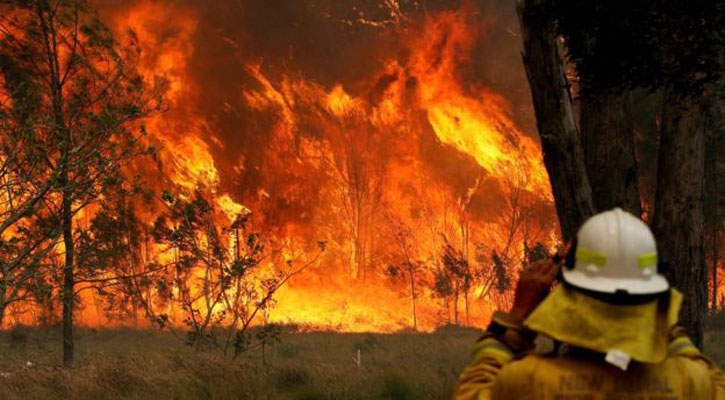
[{"xmin": 580, "ymin": 90, "xmax": 642, "ymax": 216}]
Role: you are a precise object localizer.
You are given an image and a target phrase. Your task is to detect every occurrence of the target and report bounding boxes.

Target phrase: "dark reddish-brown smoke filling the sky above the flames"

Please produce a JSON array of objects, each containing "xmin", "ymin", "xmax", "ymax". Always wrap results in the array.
[{"xmin": 191, "ymin": 0, "xmax": 533, "ymax": 182}]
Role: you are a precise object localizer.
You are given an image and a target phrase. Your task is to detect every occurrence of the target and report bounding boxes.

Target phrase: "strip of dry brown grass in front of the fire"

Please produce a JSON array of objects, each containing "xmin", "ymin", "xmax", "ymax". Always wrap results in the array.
[{"xmin": 0, "ymin": 328, "xmax": 725, "ymax": 400}]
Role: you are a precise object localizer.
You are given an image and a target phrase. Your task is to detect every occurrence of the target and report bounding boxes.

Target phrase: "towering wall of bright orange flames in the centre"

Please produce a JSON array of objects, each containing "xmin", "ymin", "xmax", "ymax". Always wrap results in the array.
[{"xmin": 5, "ymin": 0, "xmax": 555, "ymax": 332}]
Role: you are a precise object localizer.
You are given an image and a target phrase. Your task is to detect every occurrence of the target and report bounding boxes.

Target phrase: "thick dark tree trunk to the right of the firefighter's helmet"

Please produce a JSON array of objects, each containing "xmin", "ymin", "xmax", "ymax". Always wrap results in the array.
[{"xmin": 652, "ymin": 90, "xmax": 707, "ymax": 345}]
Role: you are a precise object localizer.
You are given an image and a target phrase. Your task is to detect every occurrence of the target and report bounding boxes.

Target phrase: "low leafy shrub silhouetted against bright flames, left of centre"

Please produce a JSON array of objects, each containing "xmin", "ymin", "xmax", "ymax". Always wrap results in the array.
[{"xmin": 153, "ymin": 191, "xmax": 325, "ymax": 356}]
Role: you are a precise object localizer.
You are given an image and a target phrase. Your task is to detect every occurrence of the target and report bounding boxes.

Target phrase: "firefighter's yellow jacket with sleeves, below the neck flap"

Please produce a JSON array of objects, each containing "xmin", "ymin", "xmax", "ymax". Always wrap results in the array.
[{"xmin": 453, "ymin": 334, "xmax": 725, "ymax": 400}]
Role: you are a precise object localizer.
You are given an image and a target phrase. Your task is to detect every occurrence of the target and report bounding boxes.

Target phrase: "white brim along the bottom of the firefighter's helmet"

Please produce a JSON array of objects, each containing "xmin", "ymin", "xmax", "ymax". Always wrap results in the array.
[{"xmin": 562, "ymin": 268, "xmax": 670, "ymax": 295}]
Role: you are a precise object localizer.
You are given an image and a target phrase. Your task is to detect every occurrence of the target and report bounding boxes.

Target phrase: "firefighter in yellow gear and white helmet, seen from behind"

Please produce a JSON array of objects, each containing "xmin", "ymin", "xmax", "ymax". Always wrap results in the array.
[{"xmin": 454, "ymin": 208, "xmax": 725, "ymax": 400}]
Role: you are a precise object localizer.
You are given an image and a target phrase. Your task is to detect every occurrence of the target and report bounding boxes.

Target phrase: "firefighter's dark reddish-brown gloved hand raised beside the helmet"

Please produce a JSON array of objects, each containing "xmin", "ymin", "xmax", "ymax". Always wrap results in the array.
[{"xmin": 511, "ymin": 259, "xmax": 559, "ymax": 320}]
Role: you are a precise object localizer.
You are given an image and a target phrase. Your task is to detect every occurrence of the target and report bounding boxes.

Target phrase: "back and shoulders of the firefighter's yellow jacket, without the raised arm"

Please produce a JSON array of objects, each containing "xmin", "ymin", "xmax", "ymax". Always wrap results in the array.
[{"xmin": 493, "ymin": 354, "xmax": 725, "ymax": 400}]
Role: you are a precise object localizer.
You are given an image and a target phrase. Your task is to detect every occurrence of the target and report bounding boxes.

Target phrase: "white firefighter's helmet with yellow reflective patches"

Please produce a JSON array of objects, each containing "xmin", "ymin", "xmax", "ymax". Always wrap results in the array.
[{"xmin": 562, "ymin": 208, "xmax": 669, "ymax": 295}]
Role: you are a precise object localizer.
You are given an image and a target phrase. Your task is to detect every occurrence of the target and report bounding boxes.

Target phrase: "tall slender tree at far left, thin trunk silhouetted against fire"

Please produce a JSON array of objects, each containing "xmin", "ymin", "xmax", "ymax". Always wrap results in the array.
[{"xmin": 2, "ymin": 0, "xmax": 163, "ymax": 366}]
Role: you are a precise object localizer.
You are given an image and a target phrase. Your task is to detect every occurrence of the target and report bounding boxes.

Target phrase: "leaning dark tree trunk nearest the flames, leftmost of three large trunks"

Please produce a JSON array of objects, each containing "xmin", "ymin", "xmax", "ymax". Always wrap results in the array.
[{"xmin": 517, "ymin": 0, "xmax": 594, "ymax": 240}]
